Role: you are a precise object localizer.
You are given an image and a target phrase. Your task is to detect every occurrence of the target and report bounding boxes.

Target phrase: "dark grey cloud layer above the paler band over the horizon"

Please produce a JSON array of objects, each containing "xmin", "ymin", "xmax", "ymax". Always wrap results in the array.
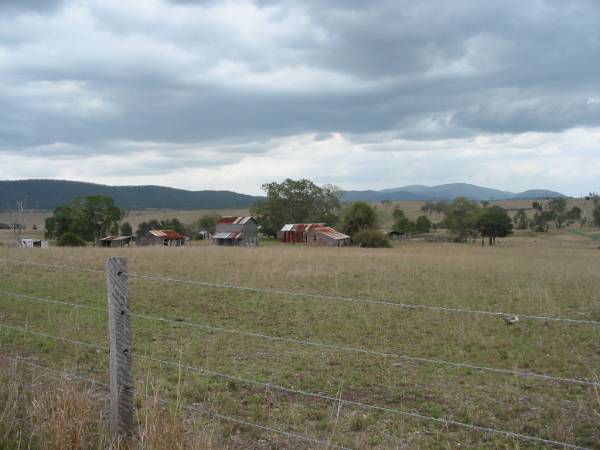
[{"xmin": 0, "ymin": 0, "xmax": 600, "ymax": 192}]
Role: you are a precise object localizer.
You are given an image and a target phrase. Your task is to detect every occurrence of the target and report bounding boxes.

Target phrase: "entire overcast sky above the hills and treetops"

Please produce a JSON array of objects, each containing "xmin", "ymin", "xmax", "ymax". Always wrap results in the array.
[{"xmin": 0, "ymin": 0, "xmax": 600, "ymax": 195}]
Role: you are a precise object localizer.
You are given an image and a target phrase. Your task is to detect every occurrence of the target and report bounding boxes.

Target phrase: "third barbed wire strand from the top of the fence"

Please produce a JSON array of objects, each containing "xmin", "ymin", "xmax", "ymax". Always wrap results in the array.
[{"xmin": 0, "ymin": 324, "xmax": 590, "ymax": 450}]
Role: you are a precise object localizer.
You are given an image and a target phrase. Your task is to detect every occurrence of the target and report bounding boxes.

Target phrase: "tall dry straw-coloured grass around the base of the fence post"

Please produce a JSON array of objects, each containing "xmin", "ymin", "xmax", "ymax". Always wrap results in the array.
[{"xmin": 0, "ymin": 355, "xmax": 227, "ymax": 450}]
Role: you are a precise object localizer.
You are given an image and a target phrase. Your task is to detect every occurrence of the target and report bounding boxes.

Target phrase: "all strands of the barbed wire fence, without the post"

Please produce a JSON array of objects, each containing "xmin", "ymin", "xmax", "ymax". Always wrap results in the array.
[{"xmin": 0, "ymin": 258, "xmax": 600, "ymax": 449}]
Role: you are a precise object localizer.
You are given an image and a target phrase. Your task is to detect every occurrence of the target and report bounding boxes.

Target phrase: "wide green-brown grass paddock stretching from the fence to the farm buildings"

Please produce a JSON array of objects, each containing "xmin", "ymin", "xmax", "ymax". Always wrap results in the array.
[{"xmin": 0, "ymin": 233, "xmax": 600, "ymax": 449}]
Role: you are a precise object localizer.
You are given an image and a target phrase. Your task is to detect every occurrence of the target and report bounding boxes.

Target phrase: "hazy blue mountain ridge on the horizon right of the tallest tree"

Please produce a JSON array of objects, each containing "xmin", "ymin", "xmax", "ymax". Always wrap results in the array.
[{"xmin": 342, "ymin": 183, "xmax": 566, "ymax": 202}]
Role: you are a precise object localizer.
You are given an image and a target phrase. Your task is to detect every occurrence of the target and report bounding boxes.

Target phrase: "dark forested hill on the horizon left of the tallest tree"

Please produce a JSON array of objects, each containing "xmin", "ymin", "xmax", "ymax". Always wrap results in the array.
[{"xmin": 0, "ymin": 180, "xmax": 259, "ymax": 210}]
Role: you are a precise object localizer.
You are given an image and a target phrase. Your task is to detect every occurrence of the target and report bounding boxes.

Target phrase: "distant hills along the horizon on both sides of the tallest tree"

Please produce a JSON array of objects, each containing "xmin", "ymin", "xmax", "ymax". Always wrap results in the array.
[{"xmin": 0, "ymin": 180, "xmax": 564, "ymax": 210}]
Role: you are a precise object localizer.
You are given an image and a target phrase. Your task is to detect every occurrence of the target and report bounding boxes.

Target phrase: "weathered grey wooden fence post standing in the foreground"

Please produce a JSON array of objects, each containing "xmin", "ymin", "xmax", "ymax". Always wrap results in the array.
[{"xmin": 106, "ymin": 257, "xmax": 133, "ymax": 440}]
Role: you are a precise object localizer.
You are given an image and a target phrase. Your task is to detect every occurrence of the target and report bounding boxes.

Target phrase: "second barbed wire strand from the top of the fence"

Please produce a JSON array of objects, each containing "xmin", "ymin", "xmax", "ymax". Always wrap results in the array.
[{"xmin": 0, "ymin": 291, "xmax": 600, "ymax": 387}]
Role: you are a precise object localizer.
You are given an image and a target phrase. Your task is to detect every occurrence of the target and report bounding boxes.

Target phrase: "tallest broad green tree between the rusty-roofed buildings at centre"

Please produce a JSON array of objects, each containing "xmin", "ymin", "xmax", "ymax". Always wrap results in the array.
[{"xmin": 251, "ymin": 178, "xmax": 340, "ymax": 237}]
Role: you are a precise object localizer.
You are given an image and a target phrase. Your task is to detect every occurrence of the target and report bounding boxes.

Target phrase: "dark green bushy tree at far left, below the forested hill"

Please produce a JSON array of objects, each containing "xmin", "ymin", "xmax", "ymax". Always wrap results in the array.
[{"xmin": 46, "ymin": 195, "xmax": 123, "ymax": 241}]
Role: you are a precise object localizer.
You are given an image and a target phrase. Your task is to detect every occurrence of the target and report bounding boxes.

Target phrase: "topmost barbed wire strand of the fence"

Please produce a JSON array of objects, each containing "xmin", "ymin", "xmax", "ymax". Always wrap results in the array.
[{"xmin": 0, "ymin": 258, "xmax": 600, "ymax": 326}]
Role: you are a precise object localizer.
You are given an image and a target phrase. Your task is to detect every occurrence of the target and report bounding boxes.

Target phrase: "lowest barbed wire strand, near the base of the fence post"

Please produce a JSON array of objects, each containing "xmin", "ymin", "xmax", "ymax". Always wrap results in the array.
[{"xmin": 0, "ymin": 355, "xmax": 352, "ymax": 450}]
